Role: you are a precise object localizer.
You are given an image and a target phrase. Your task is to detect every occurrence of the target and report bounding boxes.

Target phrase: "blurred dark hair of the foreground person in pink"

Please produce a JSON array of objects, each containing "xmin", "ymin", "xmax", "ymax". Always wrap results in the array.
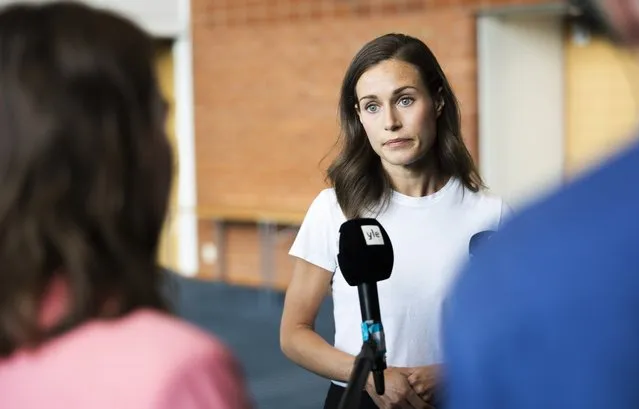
[{"xmin": 0, "ymin": 2, "xmax": 173, "ymax": 356}]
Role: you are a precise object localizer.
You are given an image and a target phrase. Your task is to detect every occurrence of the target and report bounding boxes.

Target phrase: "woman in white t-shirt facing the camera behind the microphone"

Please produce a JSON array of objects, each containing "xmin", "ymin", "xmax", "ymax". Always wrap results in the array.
[{"xmin": 280, "ymin": 34, "xmax": 506, "ymax": 408}]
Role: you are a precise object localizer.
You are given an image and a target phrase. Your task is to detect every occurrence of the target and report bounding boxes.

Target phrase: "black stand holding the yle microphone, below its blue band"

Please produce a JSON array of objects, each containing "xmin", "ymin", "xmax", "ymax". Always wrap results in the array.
[{"xmin": 338, "ymin": 337, "xmax": 386, "ymax": 409}]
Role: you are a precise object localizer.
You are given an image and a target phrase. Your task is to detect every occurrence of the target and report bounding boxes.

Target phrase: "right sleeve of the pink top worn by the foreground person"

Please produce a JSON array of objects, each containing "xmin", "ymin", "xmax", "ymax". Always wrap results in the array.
[{"xmin": 156, "ymin": 345, "xmax": 253, "ymax": 409}]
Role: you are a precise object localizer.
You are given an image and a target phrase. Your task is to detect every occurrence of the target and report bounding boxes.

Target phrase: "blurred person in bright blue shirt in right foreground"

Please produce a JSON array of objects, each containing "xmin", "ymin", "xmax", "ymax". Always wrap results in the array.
[{"xmin": 443, "ymin": 0, "xmax": 639, "ymax": 409}]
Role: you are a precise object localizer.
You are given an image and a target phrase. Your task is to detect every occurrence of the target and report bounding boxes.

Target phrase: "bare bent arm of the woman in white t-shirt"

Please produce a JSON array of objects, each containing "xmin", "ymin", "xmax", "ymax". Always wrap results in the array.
[{"xmin": 280, "ymin": 259, "xmax": 355, "ymax": 382}]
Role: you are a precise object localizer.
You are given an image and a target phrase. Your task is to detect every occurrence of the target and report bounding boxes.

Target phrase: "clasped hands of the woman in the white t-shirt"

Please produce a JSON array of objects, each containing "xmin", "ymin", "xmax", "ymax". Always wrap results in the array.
[{"xmin": 366, "ymin": 368, "xmax": 433, "ymax": 409}]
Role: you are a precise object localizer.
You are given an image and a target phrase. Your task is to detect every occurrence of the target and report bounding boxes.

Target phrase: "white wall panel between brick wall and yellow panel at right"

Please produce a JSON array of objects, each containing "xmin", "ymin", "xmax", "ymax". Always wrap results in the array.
[{"xmin": 477, "ymin": 13, "xmax": 564, "ymax": 207}]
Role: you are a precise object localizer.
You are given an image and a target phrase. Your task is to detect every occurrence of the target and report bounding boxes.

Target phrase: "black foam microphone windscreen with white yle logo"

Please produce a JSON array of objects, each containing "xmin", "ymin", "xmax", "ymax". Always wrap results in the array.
[{"xmin": 337, "ymin": 218, "xmax": 394, "ymax": 286}]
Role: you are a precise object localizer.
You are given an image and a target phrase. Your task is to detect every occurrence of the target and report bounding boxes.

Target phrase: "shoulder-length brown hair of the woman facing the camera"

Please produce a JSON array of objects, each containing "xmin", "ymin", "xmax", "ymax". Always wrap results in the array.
[{"xmin": 327, "ymin": 34, "xmax": 484, "ymax": 218}]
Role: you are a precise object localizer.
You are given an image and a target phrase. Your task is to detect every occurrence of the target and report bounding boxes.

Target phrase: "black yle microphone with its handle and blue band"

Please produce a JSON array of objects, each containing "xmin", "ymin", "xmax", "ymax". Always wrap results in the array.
[{"xmin": 337, "ymin": 218, "xmax": 394, "ymax": 395}]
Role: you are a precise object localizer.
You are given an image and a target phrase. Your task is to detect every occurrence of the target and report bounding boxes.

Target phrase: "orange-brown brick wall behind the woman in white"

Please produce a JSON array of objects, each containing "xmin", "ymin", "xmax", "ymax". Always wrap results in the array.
[{"xmin": 192, "ymin": 0, "xmax": 544, "ymax": 286}]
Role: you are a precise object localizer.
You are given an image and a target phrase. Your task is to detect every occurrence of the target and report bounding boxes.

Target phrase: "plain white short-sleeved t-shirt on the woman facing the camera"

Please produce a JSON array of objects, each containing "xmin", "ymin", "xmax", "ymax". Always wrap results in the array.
[{"xmin": 289, "ymin": 178, "xmax": 508, "ymax": 385}]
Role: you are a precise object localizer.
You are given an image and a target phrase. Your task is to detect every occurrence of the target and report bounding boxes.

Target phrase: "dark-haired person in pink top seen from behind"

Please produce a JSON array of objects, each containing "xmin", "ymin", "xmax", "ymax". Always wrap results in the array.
[{"xmin": 0, "ymin": 2, "xmax": 249, "ymax": 409}]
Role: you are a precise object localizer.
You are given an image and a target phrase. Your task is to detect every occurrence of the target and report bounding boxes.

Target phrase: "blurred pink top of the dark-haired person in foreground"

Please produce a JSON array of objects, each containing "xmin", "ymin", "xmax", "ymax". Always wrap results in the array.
[{"xmin": 0, "ymin": 280, "xmax": 251, "ymax": 409}]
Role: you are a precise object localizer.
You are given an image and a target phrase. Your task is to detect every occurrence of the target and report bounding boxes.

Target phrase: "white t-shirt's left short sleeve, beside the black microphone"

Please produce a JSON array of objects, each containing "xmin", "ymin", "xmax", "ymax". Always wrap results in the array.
[{"xmin": 289, "ymin": 189, "xmax": 339, "ymax": 273}]
